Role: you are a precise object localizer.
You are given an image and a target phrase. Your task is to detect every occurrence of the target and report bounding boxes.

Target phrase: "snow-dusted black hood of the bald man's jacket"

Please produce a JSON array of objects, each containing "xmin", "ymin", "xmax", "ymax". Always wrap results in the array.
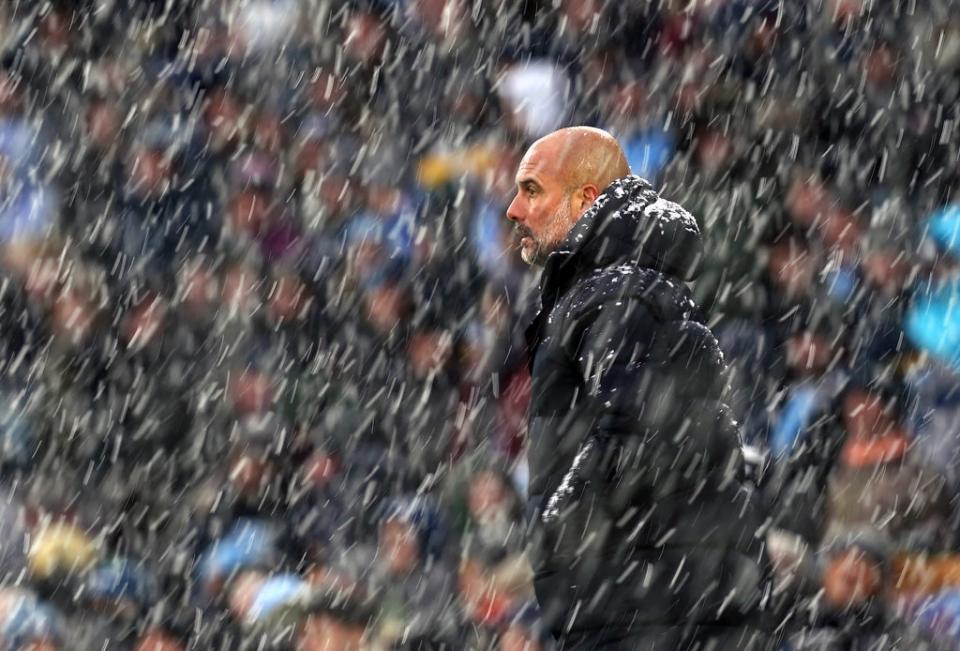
[{"xmin": 548, "ymin": 176, "xmax": 703, "ymax": 281}]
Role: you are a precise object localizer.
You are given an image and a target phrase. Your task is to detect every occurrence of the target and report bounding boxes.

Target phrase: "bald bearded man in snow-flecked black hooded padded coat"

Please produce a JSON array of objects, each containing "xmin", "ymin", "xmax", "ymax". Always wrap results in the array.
[{"xmin": 507, "ymin": 127, "xmax": 775, "ymax": 651}]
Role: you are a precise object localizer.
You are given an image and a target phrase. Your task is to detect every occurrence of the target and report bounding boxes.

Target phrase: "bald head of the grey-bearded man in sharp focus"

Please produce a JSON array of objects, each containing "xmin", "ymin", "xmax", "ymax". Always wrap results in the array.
[{"xmin": 507, "ymin": 127, "xmax": 630, "ymax": 265}]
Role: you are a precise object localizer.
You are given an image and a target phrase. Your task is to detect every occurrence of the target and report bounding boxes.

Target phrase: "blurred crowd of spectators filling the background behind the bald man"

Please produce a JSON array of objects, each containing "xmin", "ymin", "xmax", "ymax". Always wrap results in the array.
[{"xmin": 0, "ymin": 0, "xmax": 960, "ymax": 651}]
